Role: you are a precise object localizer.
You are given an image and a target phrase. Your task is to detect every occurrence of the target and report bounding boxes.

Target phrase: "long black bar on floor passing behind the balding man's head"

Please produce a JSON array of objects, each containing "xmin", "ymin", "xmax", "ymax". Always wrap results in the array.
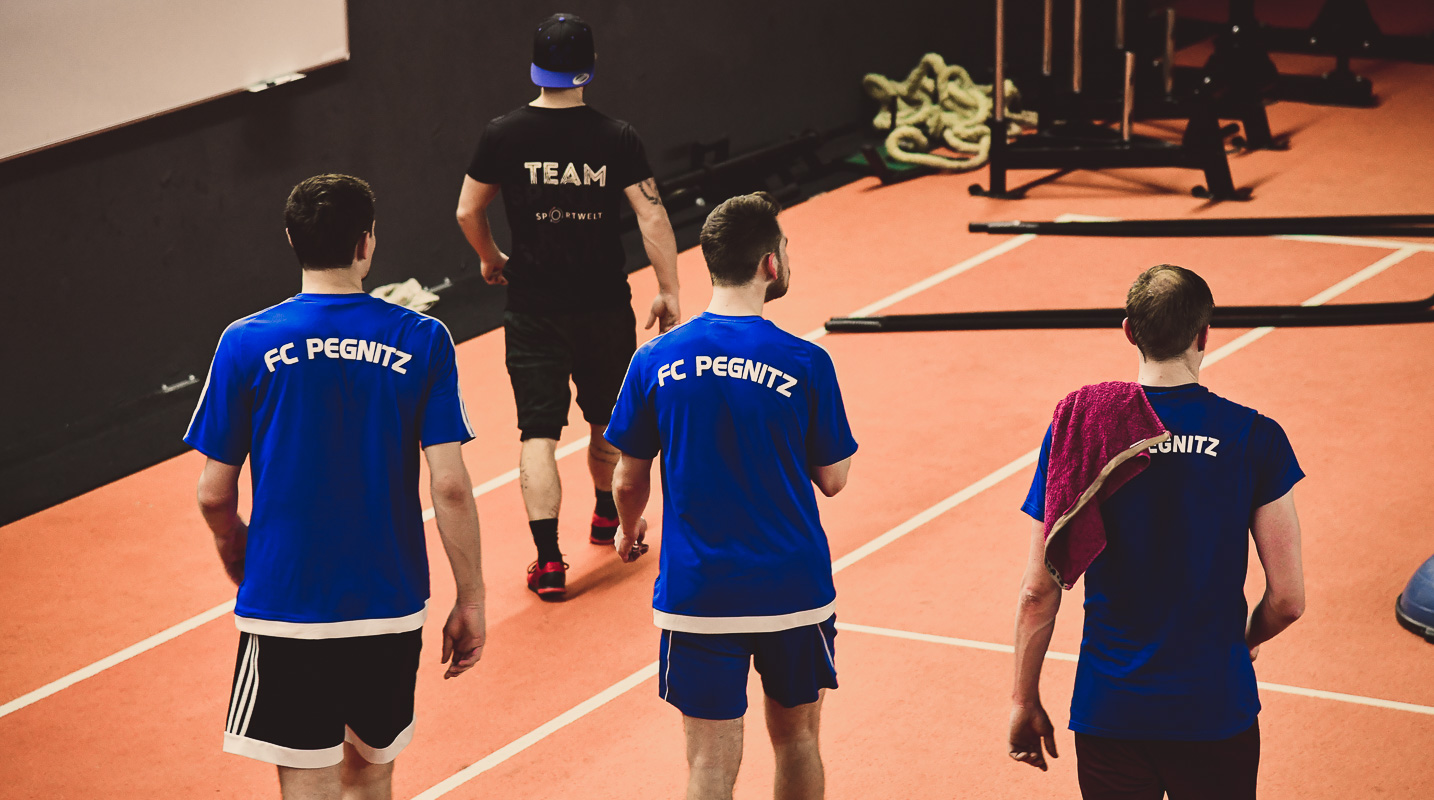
[{"xmin": 826, "ymin": 295, "xmax": 1434, "ymax": 333}]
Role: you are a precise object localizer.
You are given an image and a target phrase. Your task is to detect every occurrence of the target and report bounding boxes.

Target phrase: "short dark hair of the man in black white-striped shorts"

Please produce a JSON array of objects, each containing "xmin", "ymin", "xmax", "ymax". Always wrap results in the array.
[{"xmin": 284, "ymin": 175, "xmax": 373, "ymax": 270}]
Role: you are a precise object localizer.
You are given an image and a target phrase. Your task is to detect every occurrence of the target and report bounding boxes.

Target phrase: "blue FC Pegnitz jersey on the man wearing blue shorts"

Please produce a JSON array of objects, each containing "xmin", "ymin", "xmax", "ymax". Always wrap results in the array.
[{"xmin": 607, "ymin": 314, "xmax": 856, "ymax": 634}]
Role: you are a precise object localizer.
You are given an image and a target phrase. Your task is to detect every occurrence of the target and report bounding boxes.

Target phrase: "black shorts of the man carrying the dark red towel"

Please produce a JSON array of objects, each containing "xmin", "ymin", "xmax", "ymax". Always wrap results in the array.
[{"xmin": 1076, "ymin": 720, "xmax": 1259, "ymax": 800}]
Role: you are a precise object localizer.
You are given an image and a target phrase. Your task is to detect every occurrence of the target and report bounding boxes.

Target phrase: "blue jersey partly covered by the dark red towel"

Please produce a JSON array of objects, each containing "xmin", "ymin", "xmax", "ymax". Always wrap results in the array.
[{"xmin": 1021, "ymin": 384, "xmax": 1305, "ymax": 741}]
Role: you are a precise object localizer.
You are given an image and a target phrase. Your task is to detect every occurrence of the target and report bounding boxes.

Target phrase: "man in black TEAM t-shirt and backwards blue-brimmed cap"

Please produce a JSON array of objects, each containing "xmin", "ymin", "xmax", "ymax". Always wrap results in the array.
[{"xmin": 457, "ymin": 14, "xmax": 678, "ymax": 599}]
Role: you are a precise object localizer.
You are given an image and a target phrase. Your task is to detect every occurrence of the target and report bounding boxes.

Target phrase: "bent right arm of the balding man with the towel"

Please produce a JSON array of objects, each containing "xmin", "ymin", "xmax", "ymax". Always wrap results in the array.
[{"xmin": 1245, "ymin": 490, "xmax": 1305, "ymax": 658}]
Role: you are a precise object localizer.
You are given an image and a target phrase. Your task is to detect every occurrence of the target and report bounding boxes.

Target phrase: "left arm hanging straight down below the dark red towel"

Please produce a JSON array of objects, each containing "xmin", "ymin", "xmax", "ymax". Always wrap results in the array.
[{"xmin": 1010, "ymin": 520, "xmax": 1061, "ymax": 770}]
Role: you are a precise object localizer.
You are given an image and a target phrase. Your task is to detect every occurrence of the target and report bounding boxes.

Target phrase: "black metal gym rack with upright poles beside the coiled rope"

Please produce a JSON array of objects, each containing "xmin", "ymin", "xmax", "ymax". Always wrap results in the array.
[{"xmin": 971, "ymin": 0, "xmax": 1271, "ymax": 199}]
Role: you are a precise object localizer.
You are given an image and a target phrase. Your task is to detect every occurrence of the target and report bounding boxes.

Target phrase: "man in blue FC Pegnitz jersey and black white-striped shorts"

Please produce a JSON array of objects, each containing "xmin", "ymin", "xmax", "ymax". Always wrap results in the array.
[{"xmin": 185, "ymin": 175, "xmax": 485, "ymax": 800}]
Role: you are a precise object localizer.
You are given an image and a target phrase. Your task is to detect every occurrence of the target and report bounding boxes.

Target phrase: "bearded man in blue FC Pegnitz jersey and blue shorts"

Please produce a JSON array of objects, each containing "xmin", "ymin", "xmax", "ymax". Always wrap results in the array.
[{"xmin": 607, "ymin": 192, "xmax": 856, "ymax": 800}]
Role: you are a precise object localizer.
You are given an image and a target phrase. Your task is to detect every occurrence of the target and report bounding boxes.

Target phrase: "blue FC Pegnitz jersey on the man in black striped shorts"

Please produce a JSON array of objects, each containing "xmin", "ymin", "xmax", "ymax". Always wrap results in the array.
[{"xmin": 184, "ymin": 292, "xmax": 473, "ymax": 638}]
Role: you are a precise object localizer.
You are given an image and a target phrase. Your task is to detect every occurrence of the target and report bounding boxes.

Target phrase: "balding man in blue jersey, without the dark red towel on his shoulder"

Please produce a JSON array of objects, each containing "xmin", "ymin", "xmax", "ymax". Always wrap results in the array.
[{"xmin": 1010, "ymin": 264, "xmax": 1305, "ymax": 800}]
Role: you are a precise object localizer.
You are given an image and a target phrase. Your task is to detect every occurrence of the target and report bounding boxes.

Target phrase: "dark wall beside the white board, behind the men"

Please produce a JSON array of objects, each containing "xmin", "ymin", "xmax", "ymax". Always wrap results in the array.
[{"xmin": 0, "ymin": 0, "xmax": 989, "ymax": 453}]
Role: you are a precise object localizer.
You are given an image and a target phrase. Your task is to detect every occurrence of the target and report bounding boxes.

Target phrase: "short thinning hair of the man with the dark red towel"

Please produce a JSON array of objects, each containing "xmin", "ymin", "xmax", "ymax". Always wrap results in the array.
[{"xmin": 1126, "ymin": 264, "xmax": 1215, "ymax": 361}]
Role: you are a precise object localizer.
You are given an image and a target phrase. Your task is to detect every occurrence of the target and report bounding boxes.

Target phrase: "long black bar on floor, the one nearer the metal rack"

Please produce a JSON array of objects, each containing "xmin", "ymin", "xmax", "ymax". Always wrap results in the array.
[{"xmin": 968, "ymin": 214, "xmax": 1434, "ymax": 237}]
